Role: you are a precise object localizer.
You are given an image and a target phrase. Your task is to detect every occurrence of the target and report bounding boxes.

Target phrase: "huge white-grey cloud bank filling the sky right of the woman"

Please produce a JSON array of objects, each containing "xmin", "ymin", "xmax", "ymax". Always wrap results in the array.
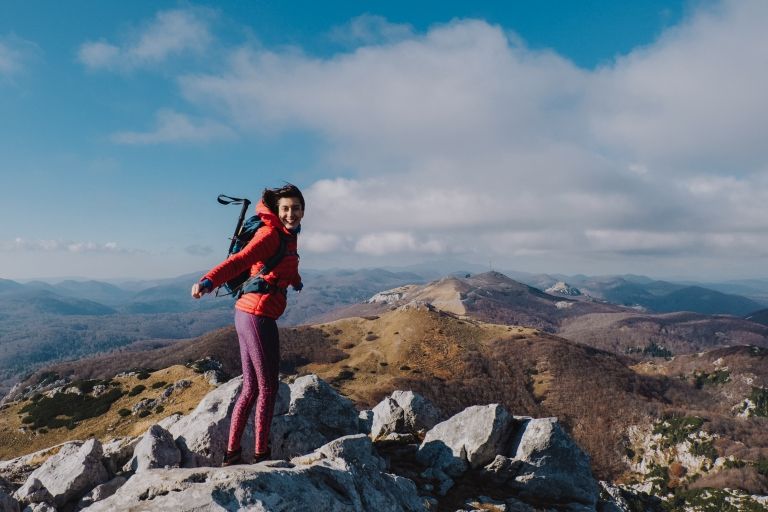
[{"xmin": 160, "ymin": 0, "xmax": 768, "ymax": 274}]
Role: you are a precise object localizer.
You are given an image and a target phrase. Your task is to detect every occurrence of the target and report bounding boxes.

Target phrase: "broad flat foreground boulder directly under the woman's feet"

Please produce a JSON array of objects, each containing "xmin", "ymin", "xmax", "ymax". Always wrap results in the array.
[{"xmin": 88, "ymin": 435, "xmax": 428, "ymax": 512}]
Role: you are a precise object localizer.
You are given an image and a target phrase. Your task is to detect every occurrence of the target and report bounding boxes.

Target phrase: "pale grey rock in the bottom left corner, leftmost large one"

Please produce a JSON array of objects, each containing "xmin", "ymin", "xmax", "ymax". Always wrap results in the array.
[{"xmin": 16, "ymin": 439, "xmax": 109, "ymax": 507}]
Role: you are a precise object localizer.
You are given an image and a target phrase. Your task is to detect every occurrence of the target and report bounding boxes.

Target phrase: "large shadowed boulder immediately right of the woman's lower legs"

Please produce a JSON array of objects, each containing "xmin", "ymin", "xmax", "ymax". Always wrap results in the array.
[{"xmin": 270, "ymin": 375, "xmax": 358, "ymax": 459}]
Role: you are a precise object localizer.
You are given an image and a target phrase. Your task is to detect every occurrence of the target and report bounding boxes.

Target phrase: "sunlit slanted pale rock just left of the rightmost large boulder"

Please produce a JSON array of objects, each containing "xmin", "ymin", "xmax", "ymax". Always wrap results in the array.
[{"xmin": 417, "ymin": 404, "xmax": 515, "ymax": 476}]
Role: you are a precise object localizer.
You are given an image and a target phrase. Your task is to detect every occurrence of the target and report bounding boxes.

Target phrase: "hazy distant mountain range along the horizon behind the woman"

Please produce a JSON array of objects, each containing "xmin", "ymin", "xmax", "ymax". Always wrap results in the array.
[{"xmin": 0, "ymin": 266, "xmax": 768, "ymax": 393}]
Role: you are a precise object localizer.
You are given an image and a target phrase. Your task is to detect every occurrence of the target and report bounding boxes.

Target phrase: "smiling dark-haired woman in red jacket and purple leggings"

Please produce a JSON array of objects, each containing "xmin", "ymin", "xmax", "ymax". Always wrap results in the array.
[{"xmin": 192, "ymin": 184, "xmax": 304, "ymax": 466}]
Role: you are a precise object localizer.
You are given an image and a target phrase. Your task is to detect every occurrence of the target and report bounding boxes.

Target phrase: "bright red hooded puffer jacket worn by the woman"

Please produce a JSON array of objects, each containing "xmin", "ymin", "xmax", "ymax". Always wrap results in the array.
[{"xmin": 203, "ymin": 201, "xmax": 301, "ymax": 320}]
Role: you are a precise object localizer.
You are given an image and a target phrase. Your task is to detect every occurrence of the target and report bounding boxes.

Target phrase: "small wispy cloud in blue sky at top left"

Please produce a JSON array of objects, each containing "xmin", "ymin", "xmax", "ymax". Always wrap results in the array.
[{"xmin": 77, "ymin": 9, "xmax": 212, "ymax": 70}]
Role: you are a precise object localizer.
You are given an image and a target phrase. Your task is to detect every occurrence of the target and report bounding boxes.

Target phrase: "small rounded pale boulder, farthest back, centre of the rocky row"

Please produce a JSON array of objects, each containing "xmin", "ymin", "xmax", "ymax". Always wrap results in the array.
[{"xmin": 370, "ymin": 391, "xmax": 440, "ymax": 441}]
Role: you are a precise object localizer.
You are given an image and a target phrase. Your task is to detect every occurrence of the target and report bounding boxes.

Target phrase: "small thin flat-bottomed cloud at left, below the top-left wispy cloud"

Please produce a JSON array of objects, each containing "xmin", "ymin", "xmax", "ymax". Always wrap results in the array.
[{"xmin": 112, "ymin": 110, "xmax": 235, "ymax": 144}]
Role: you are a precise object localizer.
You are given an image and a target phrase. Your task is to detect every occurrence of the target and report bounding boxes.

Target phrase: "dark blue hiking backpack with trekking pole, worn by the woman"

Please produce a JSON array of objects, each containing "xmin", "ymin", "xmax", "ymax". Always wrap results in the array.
[{"xmin": 216, "ymin": 194, "xmax": 288, "ymax": 299}]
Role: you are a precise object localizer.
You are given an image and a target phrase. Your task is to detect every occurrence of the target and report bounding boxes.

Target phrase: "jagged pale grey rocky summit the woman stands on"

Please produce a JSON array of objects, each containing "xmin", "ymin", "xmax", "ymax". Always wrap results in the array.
[{"xmin": 0, "ymin": 375, "xmax": 623, "ymax": 512}]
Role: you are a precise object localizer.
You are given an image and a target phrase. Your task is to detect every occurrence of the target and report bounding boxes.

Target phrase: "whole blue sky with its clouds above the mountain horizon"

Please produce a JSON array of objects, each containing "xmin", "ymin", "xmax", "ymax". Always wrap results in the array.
[{"xmin": 0, "ymin": 0, "xmax": 768, "ymax": 279}]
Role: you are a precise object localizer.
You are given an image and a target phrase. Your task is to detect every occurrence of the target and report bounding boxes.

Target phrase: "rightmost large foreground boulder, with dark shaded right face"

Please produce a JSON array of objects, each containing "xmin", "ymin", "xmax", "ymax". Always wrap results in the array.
[{"xmin": 485, "ymin": 418, "xmax": 598, "ymax": 510}]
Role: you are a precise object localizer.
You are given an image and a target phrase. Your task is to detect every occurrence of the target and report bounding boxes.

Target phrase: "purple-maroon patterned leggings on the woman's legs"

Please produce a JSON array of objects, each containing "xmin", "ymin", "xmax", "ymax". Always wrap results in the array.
[{"xmin": 227, "ymin": 309, "xmax": 280, "ymax": 453}]
